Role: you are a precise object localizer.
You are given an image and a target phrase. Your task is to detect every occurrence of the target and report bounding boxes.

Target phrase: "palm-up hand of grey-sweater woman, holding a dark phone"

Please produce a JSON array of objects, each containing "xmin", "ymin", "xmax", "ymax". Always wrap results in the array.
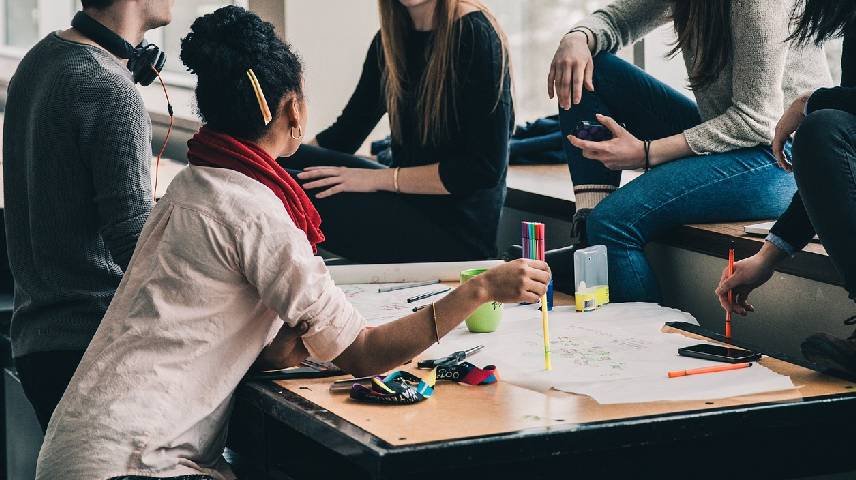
[{"xmin": 568, "ymin": 115, "xmax": 645, "ymax": 170}]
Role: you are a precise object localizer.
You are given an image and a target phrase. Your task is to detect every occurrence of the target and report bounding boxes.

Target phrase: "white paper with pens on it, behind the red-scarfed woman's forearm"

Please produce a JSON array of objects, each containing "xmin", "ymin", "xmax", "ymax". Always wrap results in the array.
[{"xmin": 339, "ymin": 283, "xmax": 449, "ymax": 326}]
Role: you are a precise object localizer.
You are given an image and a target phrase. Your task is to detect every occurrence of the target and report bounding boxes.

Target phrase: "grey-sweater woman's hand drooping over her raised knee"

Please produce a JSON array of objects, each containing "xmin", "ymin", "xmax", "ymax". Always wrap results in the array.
[{"xmin": 547, "ymin": 31, "xmax": 594, "ymax": 110}]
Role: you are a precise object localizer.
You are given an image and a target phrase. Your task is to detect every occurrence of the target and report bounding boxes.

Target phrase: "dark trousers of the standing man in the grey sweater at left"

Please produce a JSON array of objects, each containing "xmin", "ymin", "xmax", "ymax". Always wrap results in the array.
[{"xmin": 15, "ymin": 351, "xmax": 83, "ymax": 432}]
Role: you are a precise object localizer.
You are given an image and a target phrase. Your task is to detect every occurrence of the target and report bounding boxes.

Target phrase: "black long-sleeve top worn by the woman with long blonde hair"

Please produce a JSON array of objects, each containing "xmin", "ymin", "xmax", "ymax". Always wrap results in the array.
[{"xmin": 316, "ymin": 12, "xmax": 514, "ymax": 258}]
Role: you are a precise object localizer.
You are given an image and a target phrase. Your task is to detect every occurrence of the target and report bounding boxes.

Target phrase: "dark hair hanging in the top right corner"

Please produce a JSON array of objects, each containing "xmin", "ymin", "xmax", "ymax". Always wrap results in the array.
[{"xmin": 789, "ymin": 0, "xmax": 856, "ymax": 46}]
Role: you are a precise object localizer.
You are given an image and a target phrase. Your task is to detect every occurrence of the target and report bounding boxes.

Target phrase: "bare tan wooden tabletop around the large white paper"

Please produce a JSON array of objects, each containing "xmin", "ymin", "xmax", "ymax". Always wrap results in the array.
[{"xmin": 270, "ymin": 292, "xmax": 853, "ymax": 446}]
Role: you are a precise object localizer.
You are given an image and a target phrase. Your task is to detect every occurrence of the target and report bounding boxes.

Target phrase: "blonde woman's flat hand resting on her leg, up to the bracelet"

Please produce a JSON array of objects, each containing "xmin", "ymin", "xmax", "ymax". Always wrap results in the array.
[{"xmin": 297, "ymin": 167, "xmax": 393, "ymax": 198}]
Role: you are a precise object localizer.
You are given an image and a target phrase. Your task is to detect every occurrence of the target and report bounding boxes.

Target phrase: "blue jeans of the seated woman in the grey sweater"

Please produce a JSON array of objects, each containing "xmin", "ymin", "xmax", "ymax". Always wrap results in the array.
[{"xmin": 559, "ymin": 53, "xmax": 796, "ymax": 303}]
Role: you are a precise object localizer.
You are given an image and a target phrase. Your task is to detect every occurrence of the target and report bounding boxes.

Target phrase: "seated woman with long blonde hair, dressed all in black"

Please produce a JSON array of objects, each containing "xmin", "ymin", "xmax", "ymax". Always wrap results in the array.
[{"xmin": 284, "ymin": 0, "xmax": 514, "ymax": 263}]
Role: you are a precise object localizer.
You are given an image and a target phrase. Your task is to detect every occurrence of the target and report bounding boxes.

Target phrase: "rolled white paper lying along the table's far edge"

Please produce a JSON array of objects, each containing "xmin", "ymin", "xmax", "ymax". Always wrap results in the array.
[{"xmin": 329, "ymin": 260, "xmax": 502, "ymax": 286}]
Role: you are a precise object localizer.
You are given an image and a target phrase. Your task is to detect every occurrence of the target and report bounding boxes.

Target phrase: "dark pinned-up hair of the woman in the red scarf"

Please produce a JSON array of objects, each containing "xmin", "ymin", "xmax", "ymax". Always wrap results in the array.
[{"xmin": 181, "ymin": 6, "xmax": 303, "ymax": 140}]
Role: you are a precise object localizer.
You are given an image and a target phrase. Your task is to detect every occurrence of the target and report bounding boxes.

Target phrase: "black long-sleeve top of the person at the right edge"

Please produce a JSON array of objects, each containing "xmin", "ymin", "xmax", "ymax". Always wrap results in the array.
[{"xmin": 769, "ymin": 23, "xmax": 856, "ymax": 253}]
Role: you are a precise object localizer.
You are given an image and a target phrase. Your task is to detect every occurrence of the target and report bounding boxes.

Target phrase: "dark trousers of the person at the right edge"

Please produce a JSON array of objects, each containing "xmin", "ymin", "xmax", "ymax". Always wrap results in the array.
[{"xmin": 793, "ymin": 110, "xmax": 856, "ymax": 300}]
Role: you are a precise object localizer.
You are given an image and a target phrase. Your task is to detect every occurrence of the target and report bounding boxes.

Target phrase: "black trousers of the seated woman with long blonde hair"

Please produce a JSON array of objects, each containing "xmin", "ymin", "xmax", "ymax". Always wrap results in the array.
[{"xmin": 278, "ymin": 145, "xmax": 482, "ymax": 263}]
